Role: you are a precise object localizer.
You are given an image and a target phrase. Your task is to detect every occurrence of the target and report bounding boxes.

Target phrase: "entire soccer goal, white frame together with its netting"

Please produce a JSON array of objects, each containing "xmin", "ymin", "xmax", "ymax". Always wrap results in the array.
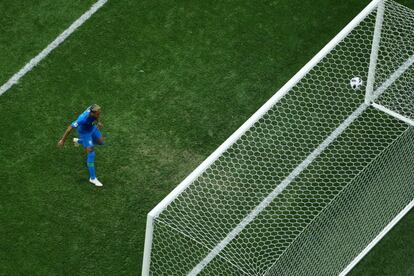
[{"xmin": 142, "ymin": 0, "xmax": 414, "ymax": 275}]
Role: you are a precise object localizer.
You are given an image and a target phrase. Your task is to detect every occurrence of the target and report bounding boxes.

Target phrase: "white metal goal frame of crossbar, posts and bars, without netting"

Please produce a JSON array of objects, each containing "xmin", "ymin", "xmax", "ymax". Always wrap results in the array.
[{"xmin": 142, "ymin": 0, "xmax": 414, "ymax": 276}]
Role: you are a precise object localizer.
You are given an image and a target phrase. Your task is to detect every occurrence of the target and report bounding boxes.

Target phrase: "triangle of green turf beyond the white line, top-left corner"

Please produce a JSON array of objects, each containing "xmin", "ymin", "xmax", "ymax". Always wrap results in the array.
[{"xmin": 0, "ymin": 0, "xmax": 94, "ymax": 84}]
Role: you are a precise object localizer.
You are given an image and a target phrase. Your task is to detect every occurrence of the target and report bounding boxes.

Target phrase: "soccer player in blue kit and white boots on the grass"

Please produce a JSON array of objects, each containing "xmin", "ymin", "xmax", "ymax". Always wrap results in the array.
[{"xmin": 58, "ymin": 104, "xmax": 104, "ymax": 187}]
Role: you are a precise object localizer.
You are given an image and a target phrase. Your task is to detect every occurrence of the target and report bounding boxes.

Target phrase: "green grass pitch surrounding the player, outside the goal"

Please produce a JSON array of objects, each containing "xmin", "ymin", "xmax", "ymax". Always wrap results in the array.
[{"xmin": 0, "ymin": 0, "xmax": 414, "ymax": 275}]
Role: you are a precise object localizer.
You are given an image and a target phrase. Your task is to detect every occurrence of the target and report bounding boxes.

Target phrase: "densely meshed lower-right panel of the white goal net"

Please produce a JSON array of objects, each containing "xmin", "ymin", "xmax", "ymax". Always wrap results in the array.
[{"xmin": 267, "ymin": 128, "xmax": 414, "ymax": 275}]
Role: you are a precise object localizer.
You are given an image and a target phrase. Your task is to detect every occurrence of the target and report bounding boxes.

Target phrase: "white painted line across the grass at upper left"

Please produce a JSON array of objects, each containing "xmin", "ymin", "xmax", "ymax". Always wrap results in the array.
[{"xmin": 0, "ymin": 0, "xmax": 108, "ymax": 96}]
